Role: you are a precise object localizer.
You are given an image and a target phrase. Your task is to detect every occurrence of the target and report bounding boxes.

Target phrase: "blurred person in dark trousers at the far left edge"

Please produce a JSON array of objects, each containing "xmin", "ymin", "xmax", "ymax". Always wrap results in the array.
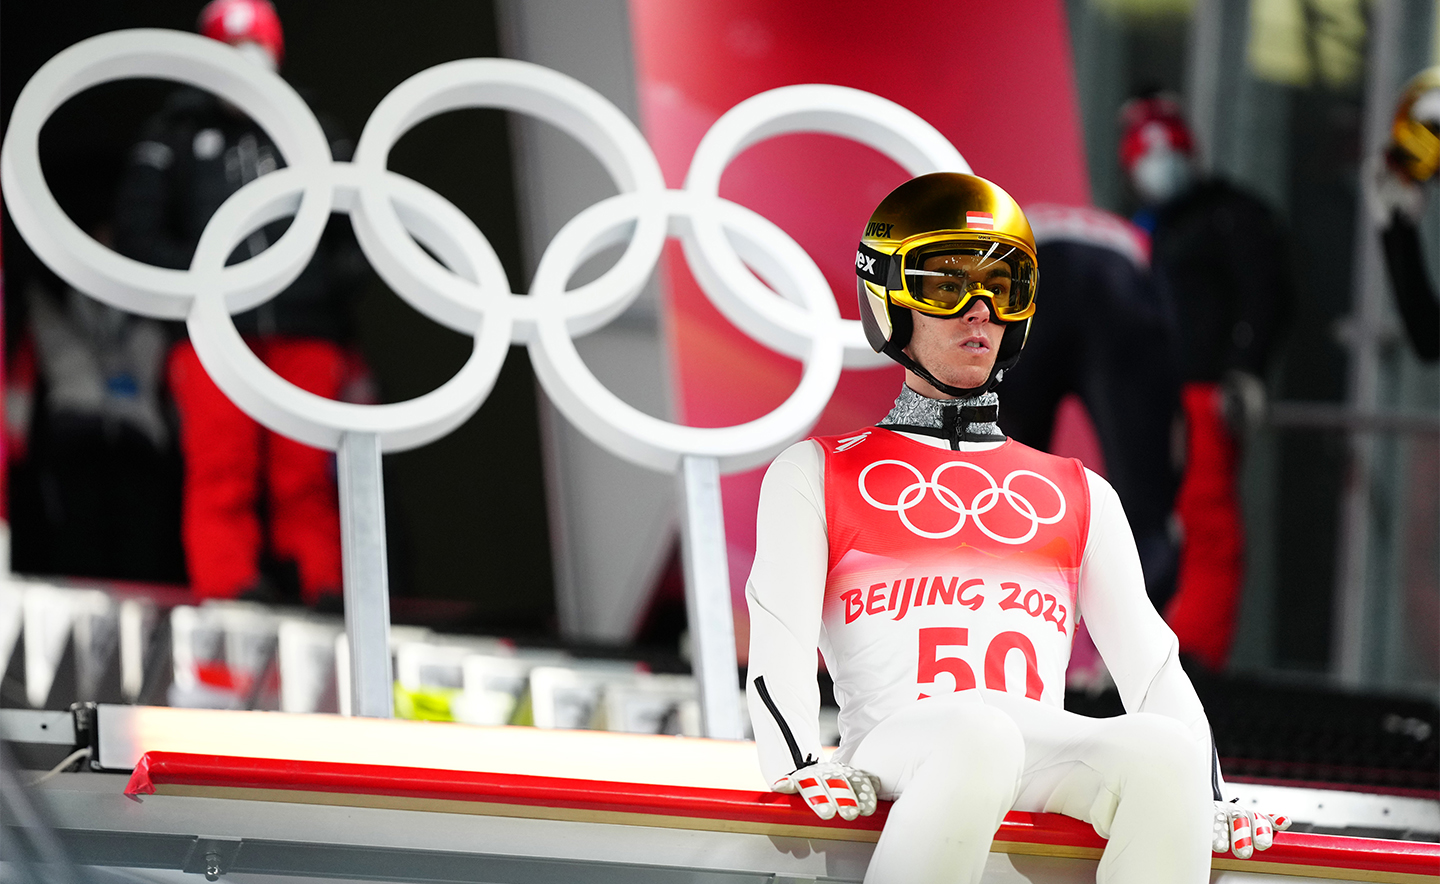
[{"xmin": 6, "ymin": 213, "xmax": 183, "ymax": 582}]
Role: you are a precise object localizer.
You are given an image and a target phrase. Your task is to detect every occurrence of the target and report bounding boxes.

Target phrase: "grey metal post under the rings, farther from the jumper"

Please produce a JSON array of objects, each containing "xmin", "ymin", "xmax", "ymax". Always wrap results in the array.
[{"xmin": 337, "ymin": 433, "xmax": 395, "ymax": 718}]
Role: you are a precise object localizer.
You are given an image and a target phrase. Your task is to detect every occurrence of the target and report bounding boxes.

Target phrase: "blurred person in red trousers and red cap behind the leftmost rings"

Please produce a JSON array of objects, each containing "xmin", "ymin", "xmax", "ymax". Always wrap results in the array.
[{"xmin": 115, "ymin": 0, "xmax": 364, "ymax": 610}]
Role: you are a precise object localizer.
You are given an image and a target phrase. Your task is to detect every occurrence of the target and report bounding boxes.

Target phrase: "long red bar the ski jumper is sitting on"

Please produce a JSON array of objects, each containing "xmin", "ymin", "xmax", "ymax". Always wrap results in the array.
[{"xmin": 125, "ymin": 752, "xmax": 1440, "ymax": 877}]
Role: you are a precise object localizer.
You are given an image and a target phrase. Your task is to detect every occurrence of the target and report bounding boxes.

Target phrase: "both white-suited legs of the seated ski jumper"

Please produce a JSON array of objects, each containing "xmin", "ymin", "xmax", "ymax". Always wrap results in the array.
[{"xmin": 848, "ymin": 690, "xmax": 1211, "ymax": 884}]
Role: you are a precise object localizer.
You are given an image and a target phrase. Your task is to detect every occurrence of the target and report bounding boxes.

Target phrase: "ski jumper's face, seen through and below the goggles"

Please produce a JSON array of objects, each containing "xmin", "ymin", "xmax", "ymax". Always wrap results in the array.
[{"xmin": 904, "ymin": 255, "xmax": 1009, "ymax": 399}]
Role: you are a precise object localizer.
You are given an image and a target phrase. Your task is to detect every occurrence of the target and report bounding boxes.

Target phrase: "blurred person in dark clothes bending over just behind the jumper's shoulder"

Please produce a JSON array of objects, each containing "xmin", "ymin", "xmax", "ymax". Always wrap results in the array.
[{"xmin": 999, "ymin": 204, "xmax": 1181, "ymax": 690}]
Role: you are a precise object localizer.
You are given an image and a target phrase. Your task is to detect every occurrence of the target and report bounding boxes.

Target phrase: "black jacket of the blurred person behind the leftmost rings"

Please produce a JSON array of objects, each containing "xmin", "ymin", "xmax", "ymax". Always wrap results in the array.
[{"xmin": 115, "ymin": 88, "xmax": 367, "ymax": 341}]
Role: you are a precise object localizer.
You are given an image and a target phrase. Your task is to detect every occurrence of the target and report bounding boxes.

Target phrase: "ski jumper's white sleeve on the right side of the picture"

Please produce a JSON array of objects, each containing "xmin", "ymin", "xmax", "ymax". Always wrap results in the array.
[{"xmin": 1079, "ymin": 469, "xmax": 1211, "ymax": 746}]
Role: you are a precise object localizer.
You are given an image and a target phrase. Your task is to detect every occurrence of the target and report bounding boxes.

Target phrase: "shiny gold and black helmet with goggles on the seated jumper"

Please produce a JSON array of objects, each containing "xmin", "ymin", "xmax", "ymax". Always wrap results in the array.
[{"xmin": 855, "ymin": 171, "xmax": 1038, "ymax": 396}]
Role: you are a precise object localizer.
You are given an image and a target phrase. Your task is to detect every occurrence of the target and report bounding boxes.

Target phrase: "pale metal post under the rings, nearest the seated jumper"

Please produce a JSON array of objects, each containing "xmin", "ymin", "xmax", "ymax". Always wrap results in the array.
[{"xmin": 677, "ymin": 456, "xmax": 744, "ymax": 740}]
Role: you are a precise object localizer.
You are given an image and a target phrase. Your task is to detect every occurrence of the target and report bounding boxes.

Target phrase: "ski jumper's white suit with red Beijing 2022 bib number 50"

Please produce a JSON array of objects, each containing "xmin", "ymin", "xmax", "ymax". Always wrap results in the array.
[{"xmin": 746, "ymin": 428, "xmax": 1212, "ymax": 884}]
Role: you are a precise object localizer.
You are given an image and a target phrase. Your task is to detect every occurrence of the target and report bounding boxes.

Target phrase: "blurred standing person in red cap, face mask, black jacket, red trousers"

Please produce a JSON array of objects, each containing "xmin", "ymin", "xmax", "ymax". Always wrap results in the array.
[{"xmin": 1120, "ymin": 96, "xmax": 1295, "ymax": 669}]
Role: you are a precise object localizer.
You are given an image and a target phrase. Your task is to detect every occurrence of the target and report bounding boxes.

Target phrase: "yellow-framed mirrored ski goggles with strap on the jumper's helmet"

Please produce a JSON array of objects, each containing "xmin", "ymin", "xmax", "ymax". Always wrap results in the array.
[{"xmin": 855, "ymin": 233, "xmax": 1037, "ymax": 323}]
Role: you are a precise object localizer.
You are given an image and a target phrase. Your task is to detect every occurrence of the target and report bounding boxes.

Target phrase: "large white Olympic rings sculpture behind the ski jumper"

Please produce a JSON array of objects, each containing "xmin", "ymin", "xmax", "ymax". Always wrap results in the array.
[{"xmin": 0, "ymin": 29, "xmax": 969, "ymax": 471}]
